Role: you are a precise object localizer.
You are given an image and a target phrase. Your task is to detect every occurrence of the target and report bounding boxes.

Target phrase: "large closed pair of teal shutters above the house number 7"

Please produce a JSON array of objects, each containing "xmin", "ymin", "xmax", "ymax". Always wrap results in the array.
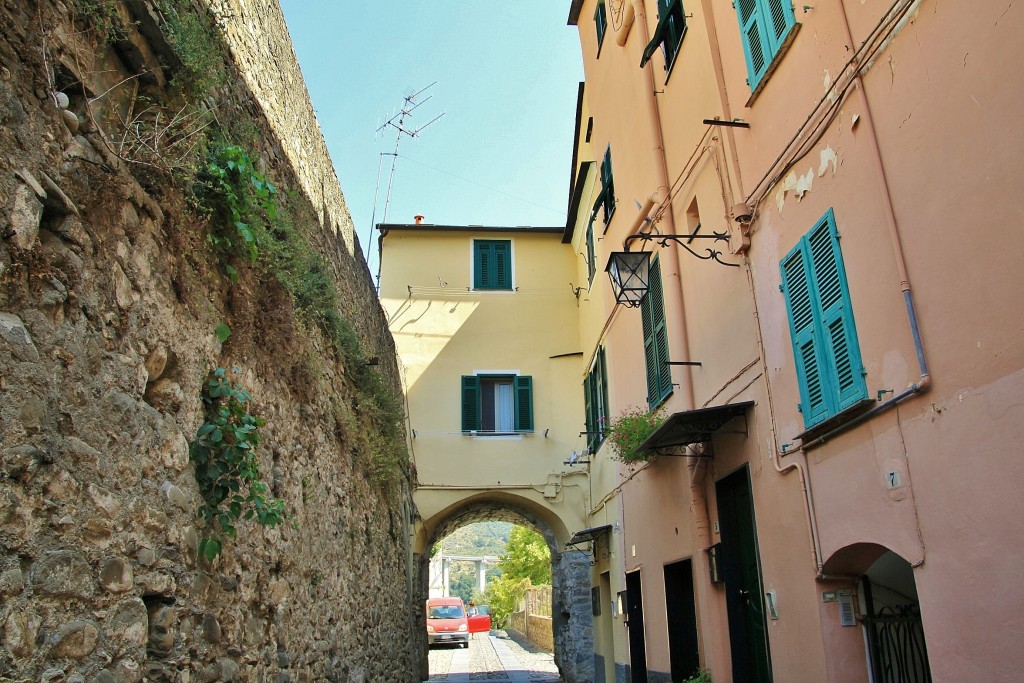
[{"xmin": 781, "ymin": 209, "xmax": 867, "ymax": 427}]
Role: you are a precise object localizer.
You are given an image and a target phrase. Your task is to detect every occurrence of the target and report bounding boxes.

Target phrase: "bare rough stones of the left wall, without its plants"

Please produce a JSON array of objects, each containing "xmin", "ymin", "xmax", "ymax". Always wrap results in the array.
[{"xmin": 0, "ymin": 0, "xmax": 422, "ymax": 683}]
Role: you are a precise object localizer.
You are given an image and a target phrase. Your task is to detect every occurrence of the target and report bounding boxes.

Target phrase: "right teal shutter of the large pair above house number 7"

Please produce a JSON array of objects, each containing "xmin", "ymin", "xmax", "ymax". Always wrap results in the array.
[{"xmin": 807, "ymin": 209, "xmax": 867, "ymax": 412}]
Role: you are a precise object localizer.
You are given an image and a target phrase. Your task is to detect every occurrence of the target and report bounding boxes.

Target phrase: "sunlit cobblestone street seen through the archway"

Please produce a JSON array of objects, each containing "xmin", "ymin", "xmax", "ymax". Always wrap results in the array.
[{"xmin": 429, "ymin": 631, "xmax": 562, "ymax": 683}]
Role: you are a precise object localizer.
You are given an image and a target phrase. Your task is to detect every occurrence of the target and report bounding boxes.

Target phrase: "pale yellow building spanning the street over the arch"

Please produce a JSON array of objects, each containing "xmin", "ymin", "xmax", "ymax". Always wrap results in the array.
[{"xmin": 379, "ymin": 223, "xmax": 592, "ymax": 681}]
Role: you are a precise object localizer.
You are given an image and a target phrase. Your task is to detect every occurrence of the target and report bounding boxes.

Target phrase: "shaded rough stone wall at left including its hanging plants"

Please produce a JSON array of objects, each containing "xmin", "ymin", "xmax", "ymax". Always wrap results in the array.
[{"xmin": 0, "ymin": 0, "xmax": 420, "ymax": 682}]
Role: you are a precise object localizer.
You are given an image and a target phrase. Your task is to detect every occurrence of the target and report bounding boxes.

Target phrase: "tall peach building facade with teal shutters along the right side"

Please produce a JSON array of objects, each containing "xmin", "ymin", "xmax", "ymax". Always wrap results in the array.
[{"xmin": 566, "ymin": 0, "xmax": 1024, "ymax": 682}]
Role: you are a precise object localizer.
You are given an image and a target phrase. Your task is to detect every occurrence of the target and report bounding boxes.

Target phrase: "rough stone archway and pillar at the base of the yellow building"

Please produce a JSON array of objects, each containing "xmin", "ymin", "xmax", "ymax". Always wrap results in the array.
[{"xmin": 419, "ymin": 496, "xmax": 594, "ymax": 683}]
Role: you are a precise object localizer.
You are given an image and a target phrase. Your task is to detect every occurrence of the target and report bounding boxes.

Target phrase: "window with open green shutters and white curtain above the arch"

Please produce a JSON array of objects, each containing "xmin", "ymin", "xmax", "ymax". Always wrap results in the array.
[{"xmin": 462, "ymin": 375, "xmax": 534, "ymax": 434}]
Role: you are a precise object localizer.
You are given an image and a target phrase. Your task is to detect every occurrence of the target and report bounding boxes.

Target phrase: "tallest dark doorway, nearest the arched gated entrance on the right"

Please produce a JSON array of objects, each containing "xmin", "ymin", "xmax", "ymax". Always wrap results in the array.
[{"xmin": 715, "ymin": 466, "xmax": 772, "ymax": 683}]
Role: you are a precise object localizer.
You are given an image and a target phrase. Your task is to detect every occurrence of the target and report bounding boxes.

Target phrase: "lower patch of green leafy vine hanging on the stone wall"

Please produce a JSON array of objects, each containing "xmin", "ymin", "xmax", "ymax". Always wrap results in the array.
[{"xmin": 188, "ymin": 368, "xmax": 285, "ymax": 560}]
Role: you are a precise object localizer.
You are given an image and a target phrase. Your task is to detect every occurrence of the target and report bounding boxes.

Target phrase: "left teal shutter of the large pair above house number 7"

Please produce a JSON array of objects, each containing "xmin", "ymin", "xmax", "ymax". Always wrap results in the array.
[{"xmin": 782, "ymin": 245, "xmax": 828, "ymax": 426}]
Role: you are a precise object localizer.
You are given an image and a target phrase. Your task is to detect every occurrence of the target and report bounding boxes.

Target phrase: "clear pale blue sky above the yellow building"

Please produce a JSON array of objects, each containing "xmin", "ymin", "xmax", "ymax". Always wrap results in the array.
[{"xmin": 281, "ymin": 0, "xmax": 583, "ymax": 274}]
